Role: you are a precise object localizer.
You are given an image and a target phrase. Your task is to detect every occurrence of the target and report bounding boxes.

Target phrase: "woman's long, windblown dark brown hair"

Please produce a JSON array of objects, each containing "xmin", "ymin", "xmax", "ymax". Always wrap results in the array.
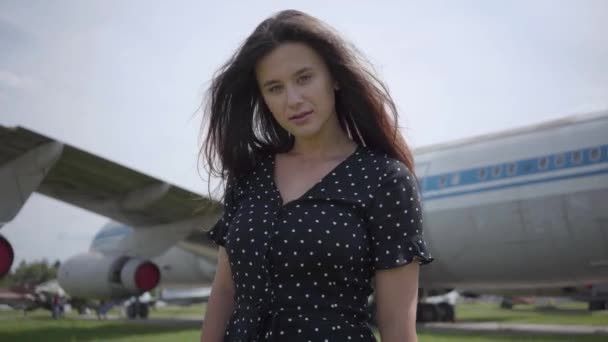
[{"xmin": 200, "ymin": 10, "xmax": 414, "ymax": 183}]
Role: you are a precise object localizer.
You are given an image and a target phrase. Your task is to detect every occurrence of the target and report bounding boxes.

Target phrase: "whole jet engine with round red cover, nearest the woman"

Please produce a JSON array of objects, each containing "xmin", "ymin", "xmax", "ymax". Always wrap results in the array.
[{"xmin": 58, "ymin": 252, "xmax": 160, "ymax": 299}]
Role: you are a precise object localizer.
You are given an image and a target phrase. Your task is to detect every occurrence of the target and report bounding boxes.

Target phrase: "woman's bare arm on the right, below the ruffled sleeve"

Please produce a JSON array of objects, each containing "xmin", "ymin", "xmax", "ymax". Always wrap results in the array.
[{"xmin": 376, "ymin": 259, "xmax": 420, "ymax": 342}]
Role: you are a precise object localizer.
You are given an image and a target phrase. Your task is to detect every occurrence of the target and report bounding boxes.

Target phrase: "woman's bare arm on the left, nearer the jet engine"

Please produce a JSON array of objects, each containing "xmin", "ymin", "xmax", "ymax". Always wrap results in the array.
[{"xmin": 201, "ymin": 246, "xmax": 234, "ymax": 342}]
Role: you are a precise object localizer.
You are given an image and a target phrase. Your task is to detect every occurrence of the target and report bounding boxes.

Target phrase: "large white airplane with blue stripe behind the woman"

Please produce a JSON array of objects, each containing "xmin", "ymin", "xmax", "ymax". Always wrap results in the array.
[{"xmin": 0, "ymin": 111, "xmax": 608, "ymax": 321}]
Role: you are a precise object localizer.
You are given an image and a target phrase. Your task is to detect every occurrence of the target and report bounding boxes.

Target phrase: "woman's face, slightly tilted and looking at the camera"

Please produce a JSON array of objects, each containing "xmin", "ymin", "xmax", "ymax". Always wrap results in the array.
[{"xmin": 255, "ymin": 43, "xmax": 340, "ymax": 139}]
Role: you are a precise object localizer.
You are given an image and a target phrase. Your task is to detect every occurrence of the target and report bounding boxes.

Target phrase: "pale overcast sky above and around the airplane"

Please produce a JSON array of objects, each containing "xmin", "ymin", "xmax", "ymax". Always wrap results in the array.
[{"xmin": 0, "ymin": 0, "xmax": 608, "ymax": 262}]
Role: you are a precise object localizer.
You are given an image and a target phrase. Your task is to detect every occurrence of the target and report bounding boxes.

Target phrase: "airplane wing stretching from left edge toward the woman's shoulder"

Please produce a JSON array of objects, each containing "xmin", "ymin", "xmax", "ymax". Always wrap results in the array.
[{"xmin": 0, "ymin": 126, "xmax": 221, "ymax": 254}]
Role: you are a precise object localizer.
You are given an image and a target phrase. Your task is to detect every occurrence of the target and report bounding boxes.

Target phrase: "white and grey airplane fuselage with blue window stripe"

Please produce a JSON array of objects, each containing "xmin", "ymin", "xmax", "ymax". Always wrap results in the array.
[{"xmin": 416, "ymin": 115, "xmax": 608, "ymax": 289}]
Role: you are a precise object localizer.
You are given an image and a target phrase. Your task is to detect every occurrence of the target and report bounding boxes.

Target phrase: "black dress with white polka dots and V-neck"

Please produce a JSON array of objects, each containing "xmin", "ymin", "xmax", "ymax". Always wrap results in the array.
[{"xmin": 208, "ymin": 146, "xmax": 433, "ymax": 342}]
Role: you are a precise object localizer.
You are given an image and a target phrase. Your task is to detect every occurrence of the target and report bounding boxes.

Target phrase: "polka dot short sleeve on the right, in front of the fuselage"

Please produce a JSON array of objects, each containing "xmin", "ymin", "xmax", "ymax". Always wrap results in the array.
[{"xmin": 367, "ymin": 159, "xmax": 433, "ymax": 269}]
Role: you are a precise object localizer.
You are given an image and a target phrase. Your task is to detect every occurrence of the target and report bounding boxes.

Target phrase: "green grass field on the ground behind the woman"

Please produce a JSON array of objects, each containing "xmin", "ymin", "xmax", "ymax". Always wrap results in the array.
[{"xmin": 0, "ymin": 303, "xmax": 608, "ymax": 342}]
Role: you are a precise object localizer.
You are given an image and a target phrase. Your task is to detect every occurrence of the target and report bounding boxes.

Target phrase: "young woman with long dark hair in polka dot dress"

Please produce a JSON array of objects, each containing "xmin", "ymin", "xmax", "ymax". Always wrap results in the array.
[{"xmin": 201, "ymin": 10, "xmax": 432, "ymax": 342}]
